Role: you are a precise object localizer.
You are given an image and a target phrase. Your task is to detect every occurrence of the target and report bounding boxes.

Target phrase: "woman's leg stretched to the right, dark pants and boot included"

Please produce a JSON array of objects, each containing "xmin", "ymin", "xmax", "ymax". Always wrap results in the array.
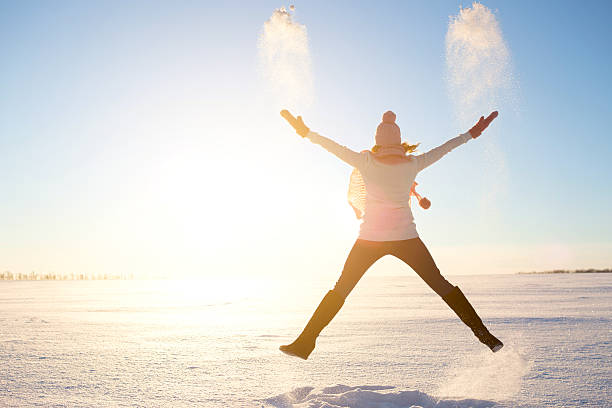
[{"xmin": 392, "ymin": 238, "xmax": 504, "ymax": 352}]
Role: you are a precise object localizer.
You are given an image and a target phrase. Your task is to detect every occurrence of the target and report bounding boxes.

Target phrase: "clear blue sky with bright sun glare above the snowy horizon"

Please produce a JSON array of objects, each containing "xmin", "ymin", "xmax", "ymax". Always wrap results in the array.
[{"xmin": 0, "ymin": 1, "xmax": 612, "ymax": 276}]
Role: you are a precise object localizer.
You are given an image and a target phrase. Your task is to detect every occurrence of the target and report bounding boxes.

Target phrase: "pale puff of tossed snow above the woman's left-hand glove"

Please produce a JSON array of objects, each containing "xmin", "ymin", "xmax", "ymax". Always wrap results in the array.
[{"xmin": 258, "ymin": 6, "xmax": 313, "ymax": 108}]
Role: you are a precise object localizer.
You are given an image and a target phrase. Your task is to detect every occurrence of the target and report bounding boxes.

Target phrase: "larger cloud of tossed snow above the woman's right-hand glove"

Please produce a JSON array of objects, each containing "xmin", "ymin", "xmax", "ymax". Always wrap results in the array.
[{"xmin": 446, "ymin": 3, "xmax": 515, "ymax": 127}]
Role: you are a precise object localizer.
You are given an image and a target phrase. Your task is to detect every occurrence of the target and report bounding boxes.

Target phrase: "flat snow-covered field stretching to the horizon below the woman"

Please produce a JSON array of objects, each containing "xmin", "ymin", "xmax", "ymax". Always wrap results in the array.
[{"xmin": 0, "ymin": 274, "xmax": 612, "ymax": 408}]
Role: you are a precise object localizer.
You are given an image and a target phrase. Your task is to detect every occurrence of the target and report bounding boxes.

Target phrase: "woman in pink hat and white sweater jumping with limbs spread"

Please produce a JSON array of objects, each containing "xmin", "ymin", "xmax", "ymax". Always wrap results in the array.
[{"xmin": 280, "ymin": 110, "xmax": 503, "ymax": 360}]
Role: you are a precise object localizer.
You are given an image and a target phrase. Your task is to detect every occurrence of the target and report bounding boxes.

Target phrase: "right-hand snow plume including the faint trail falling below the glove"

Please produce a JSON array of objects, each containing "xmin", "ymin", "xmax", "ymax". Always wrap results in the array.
[{"xmin": 446, "ymin": 3, "xmax": 517, "ymax": 218}]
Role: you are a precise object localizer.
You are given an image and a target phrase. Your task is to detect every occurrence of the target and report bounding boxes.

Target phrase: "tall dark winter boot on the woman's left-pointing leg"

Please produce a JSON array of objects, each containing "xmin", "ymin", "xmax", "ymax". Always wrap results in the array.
[{"xmin": 279, "ymin": 290, "xmax": 344, "ymax": 360}]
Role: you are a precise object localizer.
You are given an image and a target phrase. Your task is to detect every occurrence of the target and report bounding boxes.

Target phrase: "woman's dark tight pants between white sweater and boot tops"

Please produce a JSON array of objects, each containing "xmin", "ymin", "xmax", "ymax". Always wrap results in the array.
[{"xmin": 334, "ymin": 238, "xmax": 454, "ymax": 298}]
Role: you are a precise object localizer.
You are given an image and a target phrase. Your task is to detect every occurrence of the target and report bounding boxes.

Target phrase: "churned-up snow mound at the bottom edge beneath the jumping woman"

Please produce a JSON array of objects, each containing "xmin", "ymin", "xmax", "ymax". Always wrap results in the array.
[{"xmin": 261, "ymin": 385, "xmax": 496, "ymax": 408}]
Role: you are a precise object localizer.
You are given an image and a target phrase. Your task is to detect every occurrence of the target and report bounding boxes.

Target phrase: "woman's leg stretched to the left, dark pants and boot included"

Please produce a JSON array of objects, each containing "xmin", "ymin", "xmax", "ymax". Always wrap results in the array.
[{"xmin": 279, "ymin": 240, "xmax": 384, "ymax": 360}]
